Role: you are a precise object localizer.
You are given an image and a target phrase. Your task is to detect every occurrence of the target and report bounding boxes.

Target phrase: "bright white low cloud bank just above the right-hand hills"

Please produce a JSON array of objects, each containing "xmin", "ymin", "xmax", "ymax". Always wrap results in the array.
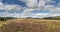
[{"xmin": 31, "ymin": 13, "xmax": 60, "ymax": 18}]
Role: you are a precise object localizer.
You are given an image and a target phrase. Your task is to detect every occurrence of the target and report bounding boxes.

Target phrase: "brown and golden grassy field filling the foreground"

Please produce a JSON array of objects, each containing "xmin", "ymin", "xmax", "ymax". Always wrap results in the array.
[{"xmin": 0, "ymin": 18, "xmax": 60, "ymax": 32}]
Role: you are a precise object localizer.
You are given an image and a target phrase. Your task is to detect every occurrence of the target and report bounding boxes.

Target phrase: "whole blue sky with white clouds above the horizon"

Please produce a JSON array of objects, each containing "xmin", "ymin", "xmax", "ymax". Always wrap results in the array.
[{"xmin": 0, "ymin": 0, "xmax": 60, "ymax": 18}]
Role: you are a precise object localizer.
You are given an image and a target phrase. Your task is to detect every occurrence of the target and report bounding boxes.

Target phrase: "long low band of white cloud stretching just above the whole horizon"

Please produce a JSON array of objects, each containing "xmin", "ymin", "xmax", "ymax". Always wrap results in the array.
[{"xmin": 1, "ymin": 13, "xmax": 60, "ymax": 18}]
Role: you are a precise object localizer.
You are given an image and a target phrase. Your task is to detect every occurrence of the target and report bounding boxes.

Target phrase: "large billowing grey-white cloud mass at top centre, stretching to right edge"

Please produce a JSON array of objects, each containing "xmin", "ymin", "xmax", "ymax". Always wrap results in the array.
[{"xmin": 19, "ymin": 0, "xmax": 60, "ymax": 15}]
